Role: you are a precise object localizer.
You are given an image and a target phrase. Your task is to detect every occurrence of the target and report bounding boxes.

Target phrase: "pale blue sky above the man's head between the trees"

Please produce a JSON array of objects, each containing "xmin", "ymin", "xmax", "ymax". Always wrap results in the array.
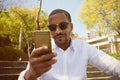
[{"xmin": 11, "ymin": 0, "xmax": 87, "ymax": 37}]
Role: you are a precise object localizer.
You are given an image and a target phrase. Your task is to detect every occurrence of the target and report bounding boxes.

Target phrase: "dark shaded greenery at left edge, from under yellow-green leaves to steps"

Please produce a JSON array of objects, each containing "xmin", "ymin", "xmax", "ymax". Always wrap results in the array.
[{"xmin": 0, "ymin": 35, "xmax": 26, "ymax": 61}]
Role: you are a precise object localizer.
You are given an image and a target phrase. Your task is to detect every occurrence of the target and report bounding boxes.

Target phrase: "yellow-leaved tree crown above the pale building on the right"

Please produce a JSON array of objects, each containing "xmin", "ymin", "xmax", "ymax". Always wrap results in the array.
[{"xmin": 78, "ymin": 0, "xmax": 120, "ymax": 36}]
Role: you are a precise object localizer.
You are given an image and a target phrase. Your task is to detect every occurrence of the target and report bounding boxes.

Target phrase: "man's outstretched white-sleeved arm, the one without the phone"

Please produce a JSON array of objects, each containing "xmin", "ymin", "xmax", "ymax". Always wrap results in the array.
[{"xmin": 87, "ymin": 42, "xmax": 120, "ymax": 76}]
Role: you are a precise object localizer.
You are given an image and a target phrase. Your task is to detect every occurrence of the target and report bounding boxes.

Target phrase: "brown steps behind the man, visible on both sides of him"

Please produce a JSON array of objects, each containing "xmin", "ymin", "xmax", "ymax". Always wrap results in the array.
[{"xmin": 0, "ymin": 61, "xmax": 114, "ymax": 80}]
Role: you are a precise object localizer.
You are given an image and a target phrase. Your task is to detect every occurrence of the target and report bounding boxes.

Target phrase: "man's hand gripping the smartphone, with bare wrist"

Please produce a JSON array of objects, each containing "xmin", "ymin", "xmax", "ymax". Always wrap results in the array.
[{"xmin": 25, "ymin": 47, "xmax": 56, "ymax": 80}]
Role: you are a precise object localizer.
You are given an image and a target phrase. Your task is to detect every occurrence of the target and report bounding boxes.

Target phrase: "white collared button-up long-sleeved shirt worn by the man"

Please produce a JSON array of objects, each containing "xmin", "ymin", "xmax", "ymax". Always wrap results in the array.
[{"xmin": 18, "ymin": 40, "xmax": 120, "ymax": 80}]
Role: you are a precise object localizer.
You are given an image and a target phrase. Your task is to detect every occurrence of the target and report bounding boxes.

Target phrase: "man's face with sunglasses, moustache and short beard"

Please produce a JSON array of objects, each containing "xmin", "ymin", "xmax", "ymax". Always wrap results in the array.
[{"xmin": 49, "ymin": 13, "xmax": 73, "ymax": 46}]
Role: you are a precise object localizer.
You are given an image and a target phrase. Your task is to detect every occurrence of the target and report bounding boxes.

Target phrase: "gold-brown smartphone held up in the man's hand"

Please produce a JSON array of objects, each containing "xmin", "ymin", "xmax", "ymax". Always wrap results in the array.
[{"xmin": 32, "ymin": 30, "xmax": 52, "ymax": 53}]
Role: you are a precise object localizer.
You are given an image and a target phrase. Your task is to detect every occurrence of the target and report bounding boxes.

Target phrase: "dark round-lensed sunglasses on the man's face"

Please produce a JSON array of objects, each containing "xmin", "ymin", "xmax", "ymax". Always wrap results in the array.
[{"xmin": 48, "ymin": 22, "xmax": 68, "ymax": 31}]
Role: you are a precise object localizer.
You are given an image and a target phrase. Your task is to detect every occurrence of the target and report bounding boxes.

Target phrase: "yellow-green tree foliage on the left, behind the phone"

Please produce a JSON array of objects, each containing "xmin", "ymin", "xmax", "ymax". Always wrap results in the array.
[{"xmin": 0, "ymin": 7, "xmax": 47, "ymax": 52}]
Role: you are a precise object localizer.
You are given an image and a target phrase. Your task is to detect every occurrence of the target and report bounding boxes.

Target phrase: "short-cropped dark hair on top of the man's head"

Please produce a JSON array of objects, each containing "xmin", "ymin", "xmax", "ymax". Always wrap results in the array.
[{"xmin": 49, "ymin": 9, "xmax": 71, "ymax": 22}]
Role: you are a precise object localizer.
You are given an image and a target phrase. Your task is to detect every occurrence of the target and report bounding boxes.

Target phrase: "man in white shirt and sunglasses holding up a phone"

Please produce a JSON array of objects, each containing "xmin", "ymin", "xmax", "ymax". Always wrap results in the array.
[{"xmin": 19, "ymin": 9, "xmax": 120, "ymax": 80}]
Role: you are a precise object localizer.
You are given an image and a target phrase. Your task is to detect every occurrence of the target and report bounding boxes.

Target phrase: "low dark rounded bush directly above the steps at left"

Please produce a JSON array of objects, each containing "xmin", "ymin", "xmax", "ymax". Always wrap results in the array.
[{"xmin": 0, "ymin": 46, "xmax": 25, "ymax": 61}]
